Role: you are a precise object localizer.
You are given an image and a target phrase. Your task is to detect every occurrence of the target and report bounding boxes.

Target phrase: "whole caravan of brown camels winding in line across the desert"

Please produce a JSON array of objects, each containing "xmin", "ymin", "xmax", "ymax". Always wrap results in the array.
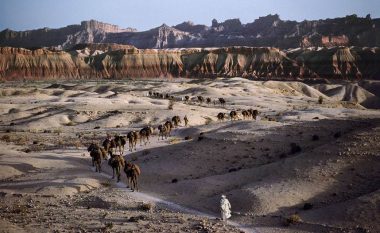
[{"xmin": 87, "ymin": 91, "xmax": 259, "ymax": 191}]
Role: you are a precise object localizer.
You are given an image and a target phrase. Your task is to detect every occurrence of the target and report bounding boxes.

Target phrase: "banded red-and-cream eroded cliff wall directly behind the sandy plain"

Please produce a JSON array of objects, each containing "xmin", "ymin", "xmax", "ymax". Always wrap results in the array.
[{"xmin": 0, "ymin": 44, "xmax": 380, "ymax": 80}]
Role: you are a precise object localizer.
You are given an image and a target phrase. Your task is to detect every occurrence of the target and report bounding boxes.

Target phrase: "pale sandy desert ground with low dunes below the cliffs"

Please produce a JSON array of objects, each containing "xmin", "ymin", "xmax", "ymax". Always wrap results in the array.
[{"xmin": 0, "ymin": 78, "xmax": 380, "ymax": 232}]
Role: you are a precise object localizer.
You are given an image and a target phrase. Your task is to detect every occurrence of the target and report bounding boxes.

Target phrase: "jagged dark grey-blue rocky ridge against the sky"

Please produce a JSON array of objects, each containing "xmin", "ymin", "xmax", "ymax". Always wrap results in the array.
[{"xmin": 0, "ymin": 15, "xmax": 380, "ymax": 49}]
